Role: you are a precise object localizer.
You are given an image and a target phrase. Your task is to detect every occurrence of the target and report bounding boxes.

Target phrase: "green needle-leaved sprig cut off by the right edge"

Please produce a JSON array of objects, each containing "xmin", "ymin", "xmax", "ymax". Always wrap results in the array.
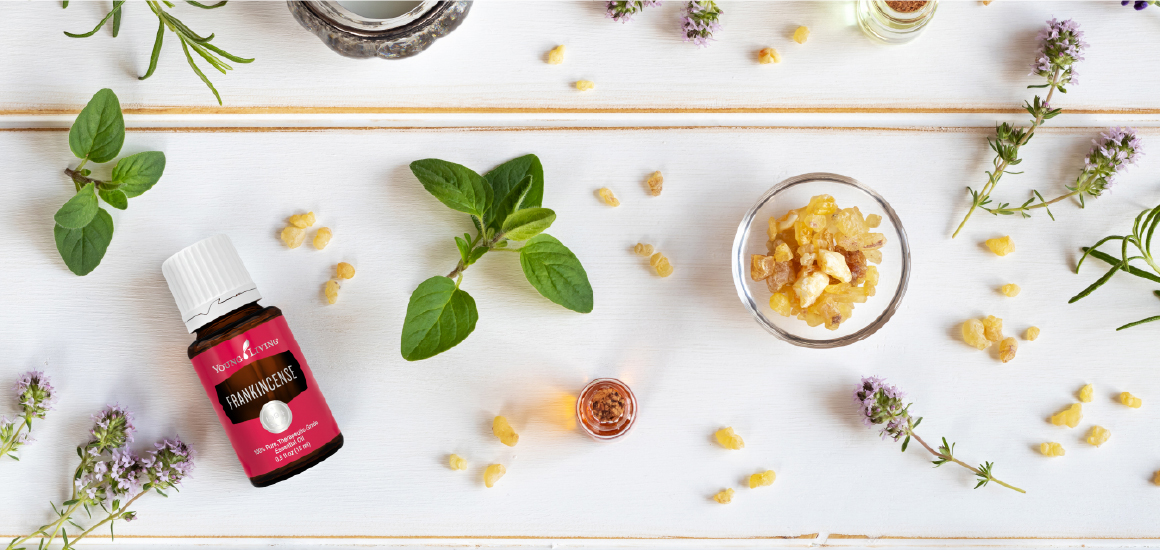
[{"xmin": 1067, "ymin": 205, "xmax": 1160, "ymax": 331}]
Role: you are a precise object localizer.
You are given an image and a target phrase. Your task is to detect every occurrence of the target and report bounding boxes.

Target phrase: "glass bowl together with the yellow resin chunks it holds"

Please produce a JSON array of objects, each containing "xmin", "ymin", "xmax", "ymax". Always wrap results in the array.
[{"xmin": 733, "ymin": 173, "xmax": 911, "ymax": 348}]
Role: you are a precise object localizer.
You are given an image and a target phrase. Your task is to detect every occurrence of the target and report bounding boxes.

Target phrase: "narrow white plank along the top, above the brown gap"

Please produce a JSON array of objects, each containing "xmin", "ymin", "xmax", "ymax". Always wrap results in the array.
[{"xmin": 0, "ymin": 0, "xmax": 1160, "ymax": 114}]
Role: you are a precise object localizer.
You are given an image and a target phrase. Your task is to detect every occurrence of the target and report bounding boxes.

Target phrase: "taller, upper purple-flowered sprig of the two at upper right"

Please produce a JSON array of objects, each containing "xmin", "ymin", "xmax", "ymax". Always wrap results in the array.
[{"xmin": 951, "ymin": 19, "xmax": 1088, "ymax": 238}]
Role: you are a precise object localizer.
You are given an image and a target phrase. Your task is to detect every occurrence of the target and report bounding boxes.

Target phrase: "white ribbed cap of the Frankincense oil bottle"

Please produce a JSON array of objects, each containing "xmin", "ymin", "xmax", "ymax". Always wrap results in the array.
[{"xmin": 161, "ymin": 234, "xmax": 262, "ymax": 332}]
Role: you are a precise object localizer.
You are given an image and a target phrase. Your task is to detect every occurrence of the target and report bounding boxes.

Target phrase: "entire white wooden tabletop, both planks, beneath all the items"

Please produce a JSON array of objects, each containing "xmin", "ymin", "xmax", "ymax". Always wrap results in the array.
[{"xmin": 0, "ymin": 1, "xmax": 1160, "ymax": 548}]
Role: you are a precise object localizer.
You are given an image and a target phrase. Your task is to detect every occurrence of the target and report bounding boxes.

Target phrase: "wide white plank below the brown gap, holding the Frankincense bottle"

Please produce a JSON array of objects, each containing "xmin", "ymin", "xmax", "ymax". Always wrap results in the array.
[{"xmin": 0, "ymin": 129, "xmax": 1160, "ymax": 548}]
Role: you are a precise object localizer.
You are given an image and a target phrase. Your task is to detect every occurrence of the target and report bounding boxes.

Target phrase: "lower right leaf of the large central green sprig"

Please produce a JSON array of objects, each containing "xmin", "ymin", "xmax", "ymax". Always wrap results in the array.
[{"xmin": 520, "ymin": 233, "xmax": 593, "ymax": 313}]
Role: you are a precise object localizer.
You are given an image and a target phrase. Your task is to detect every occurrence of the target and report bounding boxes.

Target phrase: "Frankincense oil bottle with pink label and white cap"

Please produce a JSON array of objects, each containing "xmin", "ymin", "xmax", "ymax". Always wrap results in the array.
[{"xmin": 161, "ymin": 234, "xmax": 342, "ymax": 487}]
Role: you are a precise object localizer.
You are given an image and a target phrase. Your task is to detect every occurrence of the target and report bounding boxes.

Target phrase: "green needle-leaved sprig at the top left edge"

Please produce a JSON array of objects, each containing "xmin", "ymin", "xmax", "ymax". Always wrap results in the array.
[{"xmin": 63, "ymin": 0, "xmax": 254, "ymax": 104}]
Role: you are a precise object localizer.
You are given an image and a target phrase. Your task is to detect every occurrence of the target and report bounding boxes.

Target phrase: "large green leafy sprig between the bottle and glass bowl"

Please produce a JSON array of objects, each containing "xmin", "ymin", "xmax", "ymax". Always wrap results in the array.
[{"xmin": 400, "ymin": 154, "xmax": 593, "ymax": 361}]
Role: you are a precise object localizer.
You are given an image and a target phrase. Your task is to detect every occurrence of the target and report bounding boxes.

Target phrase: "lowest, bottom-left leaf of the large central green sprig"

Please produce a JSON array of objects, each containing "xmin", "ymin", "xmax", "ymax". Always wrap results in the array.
[{"xmin": 400, "ymin": 275, "xmax": 479, "ymax": 361}]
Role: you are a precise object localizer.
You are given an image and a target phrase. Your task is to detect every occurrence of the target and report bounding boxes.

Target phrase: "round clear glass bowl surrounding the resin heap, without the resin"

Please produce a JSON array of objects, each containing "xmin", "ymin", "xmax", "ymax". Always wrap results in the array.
[{"xmin": 733, "ymin": 173, "xmax": 911, "ymax": 348}]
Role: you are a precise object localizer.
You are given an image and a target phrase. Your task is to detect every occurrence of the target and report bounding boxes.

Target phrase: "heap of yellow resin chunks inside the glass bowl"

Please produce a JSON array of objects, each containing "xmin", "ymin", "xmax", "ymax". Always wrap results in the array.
[{"xmin": 749, "ymin": 195, "xmax": 886, "ymax": 331}]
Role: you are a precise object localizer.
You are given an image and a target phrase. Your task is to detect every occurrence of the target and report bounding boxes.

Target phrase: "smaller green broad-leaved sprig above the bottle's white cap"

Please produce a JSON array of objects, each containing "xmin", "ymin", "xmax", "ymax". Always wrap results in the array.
[{"xmin": 52, "ymin": 88, "xmax": 165, "ymax": 275}]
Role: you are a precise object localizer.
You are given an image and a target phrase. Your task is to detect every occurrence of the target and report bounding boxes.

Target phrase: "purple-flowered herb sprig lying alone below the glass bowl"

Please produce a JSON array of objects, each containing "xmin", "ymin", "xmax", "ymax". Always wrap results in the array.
[{"xmin": 854, "ymin": 376, "xmax": 1027, "ymax": 493}]
